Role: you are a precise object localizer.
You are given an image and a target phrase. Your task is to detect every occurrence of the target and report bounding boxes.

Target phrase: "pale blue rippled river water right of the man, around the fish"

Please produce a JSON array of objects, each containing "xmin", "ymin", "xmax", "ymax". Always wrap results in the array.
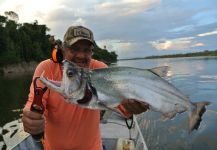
[{"xmin": 118, "ymin": 58, "xmax": 217, "ymax": 150}]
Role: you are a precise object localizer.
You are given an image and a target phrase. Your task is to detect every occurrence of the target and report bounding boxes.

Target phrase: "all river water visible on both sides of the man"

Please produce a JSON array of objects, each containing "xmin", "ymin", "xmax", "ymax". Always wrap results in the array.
[{"xmin": 0, "ymin": 57, "xmax": 217, "ymax": 150}]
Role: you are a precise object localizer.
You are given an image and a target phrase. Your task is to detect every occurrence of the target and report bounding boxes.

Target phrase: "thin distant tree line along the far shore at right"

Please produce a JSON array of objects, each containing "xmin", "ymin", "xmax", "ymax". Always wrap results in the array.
[{"xmin": 145, "ymin": 50, "xmax": 217, "ymax": 59}]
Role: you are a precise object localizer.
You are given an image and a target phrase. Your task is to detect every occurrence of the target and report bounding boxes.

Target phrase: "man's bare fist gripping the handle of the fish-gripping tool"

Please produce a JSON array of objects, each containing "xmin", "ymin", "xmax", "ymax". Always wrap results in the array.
[{"xmin": 22, "ymin": 107, "xmax": 45, "ymax": 135}]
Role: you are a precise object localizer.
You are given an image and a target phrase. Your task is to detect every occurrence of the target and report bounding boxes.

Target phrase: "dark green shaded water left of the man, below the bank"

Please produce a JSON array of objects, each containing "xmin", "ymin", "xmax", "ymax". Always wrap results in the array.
[{"xmin": 0, "ymin": 75, "xmax": 32, "ymax": 127}]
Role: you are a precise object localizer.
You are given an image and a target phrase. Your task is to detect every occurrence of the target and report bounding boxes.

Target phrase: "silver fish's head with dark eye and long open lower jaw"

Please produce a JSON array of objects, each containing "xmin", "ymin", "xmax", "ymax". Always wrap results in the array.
[{"xmin": 40, "ymin": 60, "xmax": 88, "ymax": 104}]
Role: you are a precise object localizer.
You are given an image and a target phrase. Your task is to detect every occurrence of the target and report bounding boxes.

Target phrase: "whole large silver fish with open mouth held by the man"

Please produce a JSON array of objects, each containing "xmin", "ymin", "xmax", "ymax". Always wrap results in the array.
[{"xmin": 40, "ymin": 60, "xmax": 210, "ymax": 133}]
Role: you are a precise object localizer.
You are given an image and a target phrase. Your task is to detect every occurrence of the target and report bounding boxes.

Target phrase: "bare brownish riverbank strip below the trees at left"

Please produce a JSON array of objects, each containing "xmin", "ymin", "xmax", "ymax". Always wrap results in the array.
[{"xmin": 0, "ymin": 61, "xmax": 38, "ymax": 77}]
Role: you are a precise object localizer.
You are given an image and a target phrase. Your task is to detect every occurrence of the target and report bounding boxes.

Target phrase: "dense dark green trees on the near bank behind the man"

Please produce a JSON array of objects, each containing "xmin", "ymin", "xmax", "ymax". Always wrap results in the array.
[{"xmin": 0, "ymin": 11, "xmax": 117, "ymax": 66}]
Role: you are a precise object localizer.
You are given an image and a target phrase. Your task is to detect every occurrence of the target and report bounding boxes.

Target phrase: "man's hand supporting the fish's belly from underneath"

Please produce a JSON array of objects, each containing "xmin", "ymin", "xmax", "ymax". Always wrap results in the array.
[{"xmin": 117, "ymin": 99, "xmax": 149, "ymax": 118}]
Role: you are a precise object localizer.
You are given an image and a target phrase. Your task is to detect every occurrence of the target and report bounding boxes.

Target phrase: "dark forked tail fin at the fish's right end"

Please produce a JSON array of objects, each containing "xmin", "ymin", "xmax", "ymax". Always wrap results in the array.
[{"xmin": 188, "ymin": 102, "xmax": 210, "ymax": 133}]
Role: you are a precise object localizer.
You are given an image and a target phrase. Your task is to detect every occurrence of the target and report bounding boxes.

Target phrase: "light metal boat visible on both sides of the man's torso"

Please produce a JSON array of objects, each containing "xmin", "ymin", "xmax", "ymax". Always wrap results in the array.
[{"xmin": 0, "ymin": 113, "xmax": 148, "ymax": 150}]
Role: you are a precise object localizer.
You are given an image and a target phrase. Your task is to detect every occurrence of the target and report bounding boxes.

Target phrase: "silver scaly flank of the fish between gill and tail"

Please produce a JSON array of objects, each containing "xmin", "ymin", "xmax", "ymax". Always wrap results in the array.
[{"xmin": 91, "ymin": 67, "xmax": 188, "ymax": 111}]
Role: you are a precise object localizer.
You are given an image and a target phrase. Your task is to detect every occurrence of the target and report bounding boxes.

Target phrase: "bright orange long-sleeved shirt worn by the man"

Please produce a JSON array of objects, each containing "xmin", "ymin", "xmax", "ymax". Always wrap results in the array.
[{"xmin": 26, "ymin": 59, "xmax": 107, "ymax": 150}]
